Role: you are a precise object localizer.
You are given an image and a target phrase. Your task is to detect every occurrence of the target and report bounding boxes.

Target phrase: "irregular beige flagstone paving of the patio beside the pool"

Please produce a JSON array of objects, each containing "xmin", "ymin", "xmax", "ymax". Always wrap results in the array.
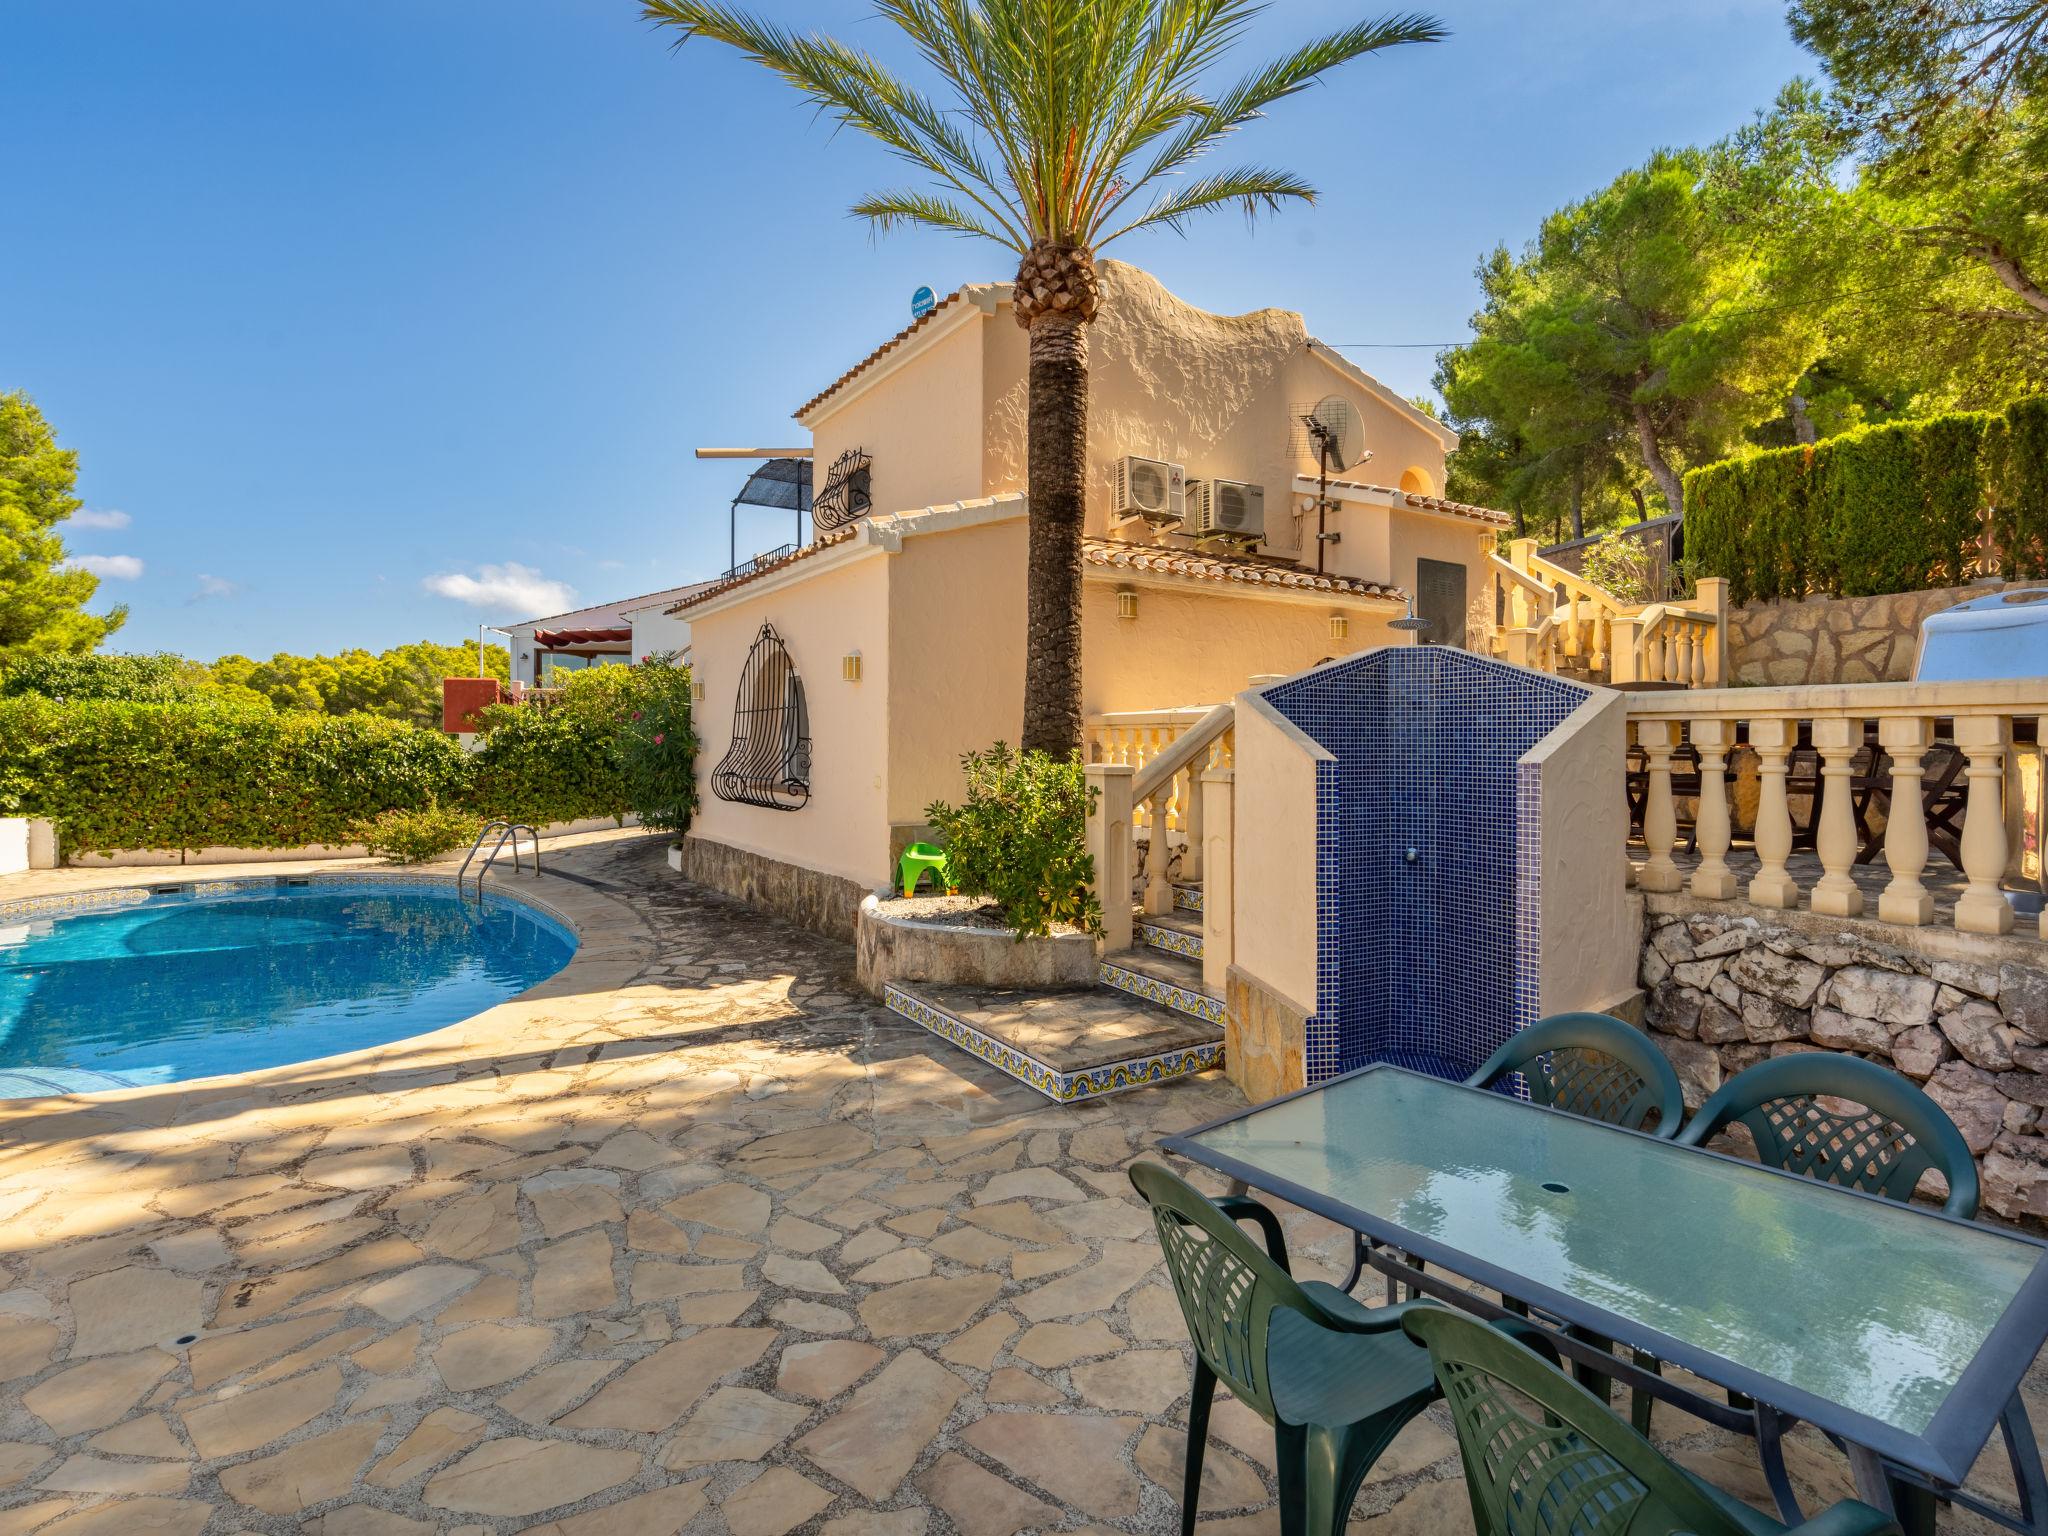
[{"xmin": 0, "ymin": 838, "xmax": 2048, "ymax": 1536}]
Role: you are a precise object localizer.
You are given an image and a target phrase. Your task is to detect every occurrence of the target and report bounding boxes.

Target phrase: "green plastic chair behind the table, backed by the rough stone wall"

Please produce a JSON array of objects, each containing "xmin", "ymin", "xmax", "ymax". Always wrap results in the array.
[{"xmin": 1679, "ymin": 1051, "xmax": 1976, "ymax": 1221}]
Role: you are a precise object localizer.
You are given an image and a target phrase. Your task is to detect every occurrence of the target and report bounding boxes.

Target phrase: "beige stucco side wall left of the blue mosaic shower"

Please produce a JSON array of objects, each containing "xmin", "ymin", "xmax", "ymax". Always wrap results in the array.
[{"xmin": 1231, "ymin": 692, "xmax": 1329, "ymax": 1018}]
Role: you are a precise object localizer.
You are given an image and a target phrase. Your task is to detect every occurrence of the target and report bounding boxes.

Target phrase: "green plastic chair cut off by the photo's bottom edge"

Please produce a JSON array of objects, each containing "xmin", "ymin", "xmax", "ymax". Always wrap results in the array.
[{"xmin": 1401, "ymin": 1307, "xmax": 1898, "ymax": 1536}]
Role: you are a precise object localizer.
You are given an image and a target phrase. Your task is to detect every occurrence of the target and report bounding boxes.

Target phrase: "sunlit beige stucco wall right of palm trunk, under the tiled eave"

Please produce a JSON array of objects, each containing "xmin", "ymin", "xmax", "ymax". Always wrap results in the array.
[{"xmin": 1081, "ymin": 580, "xmax": 1399, "ymax": 715}]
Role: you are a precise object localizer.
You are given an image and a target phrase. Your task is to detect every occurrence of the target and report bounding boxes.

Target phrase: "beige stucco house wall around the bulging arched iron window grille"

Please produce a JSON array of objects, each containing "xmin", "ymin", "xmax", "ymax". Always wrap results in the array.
[{"xmin": 690, "ymin": 545, "xmax": 889, "ymax": 889}]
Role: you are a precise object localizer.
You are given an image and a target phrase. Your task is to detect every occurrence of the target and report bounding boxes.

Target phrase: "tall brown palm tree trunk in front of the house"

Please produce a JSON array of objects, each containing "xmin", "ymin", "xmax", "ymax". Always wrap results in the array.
[{"xmin": 1024, "ymin": 313, "xmax": 1087, "ymax": 758}]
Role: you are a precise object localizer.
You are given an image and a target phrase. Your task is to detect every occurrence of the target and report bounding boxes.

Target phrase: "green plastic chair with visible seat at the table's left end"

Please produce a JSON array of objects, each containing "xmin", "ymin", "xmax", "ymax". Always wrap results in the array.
[{"xmin": 1130, "ymin": 1163, "xmax": 1436, "ymax": 1536}]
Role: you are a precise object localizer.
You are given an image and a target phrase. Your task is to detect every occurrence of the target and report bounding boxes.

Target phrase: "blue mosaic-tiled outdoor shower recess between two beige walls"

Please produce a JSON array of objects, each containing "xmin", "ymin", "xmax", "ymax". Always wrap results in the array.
[{"xmin": 1262, "ymin": 645, "xmax": 1589, "ymax": 1083}]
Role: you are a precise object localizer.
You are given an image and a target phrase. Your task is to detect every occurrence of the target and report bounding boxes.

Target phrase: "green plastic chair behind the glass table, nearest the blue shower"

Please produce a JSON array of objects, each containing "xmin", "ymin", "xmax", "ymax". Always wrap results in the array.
[{"xmin": 1464, "ymin": 1014, "xmax": 1686, "ymax": 1137}]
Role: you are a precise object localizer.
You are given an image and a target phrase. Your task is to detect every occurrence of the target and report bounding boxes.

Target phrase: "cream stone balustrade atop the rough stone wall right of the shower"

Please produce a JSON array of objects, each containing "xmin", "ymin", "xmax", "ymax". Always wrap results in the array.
[{"xmin": 1628, "ymin": 680, "xmax": 2048, "ymax": 938}]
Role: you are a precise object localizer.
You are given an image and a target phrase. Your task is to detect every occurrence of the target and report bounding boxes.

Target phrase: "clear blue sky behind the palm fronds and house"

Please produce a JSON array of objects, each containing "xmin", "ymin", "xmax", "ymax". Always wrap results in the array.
[{"xmin": 0, "ymin": 0, "xmax": 1810, "ymax": 657}]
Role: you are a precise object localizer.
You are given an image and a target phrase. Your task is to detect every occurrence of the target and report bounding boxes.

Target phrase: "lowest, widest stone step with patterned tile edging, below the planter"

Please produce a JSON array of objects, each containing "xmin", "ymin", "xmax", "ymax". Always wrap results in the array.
[{"xmin": 883, "ymin": 981, "xmax": 1223, "ymax": 1104}]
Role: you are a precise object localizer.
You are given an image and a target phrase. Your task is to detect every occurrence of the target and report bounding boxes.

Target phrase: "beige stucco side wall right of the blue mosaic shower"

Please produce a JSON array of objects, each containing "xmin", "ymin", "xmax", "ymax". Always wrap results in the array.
[{"xmin": 1522, "ymin": 690, "xmax": 1642, "ymax": 1014}]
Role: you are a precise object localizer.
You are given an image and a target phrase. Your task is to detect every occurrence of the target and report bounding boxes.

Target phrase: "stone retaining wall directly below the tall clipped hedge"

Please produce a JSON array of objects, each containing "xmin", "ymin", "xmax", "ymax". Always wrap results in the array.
[{"xmin": 1726, "ymin": 582, "xmax": 2042, "ymax": 686}]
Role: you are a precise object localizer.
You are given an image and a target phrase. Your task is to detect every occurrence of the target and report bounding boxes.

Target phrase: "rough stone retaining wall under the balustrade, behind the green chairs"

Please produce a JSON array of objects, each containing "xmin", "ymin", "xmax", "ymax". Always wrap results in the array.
[{"xmin": 1642, "ymin": 897, "xmax": 2048, "ymax": 1219}]
